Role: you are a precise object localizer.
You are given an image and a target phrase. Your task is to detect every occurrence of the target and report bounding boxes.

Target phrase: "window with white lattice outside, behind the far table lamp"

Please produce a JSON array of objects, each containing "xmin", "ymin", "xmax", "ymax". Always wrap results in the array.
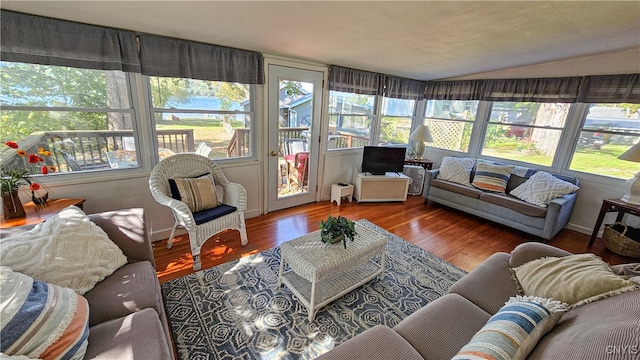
[{"xmin": 424, "ymin": 100, "xmax": 478, "ymax": 152}]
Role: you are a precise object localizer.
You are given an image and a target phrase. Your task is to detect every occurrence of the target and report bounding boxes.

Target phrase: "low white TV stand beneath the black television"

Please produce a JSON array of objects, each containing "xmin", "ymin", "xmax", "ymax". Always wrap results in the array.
[{"xmin": 353, "ymin": 167, "xmax": 410, "ymax": 202}]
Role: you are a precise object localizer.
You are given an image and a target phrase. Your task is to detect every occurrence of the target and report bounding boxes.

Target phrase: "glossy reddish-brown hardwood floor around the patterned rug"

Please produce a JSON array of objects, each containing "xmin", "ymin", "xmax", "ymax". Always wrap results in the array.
[{"xmin": 154, "ymin": 196, "xmax": 637, "ymax": 282}]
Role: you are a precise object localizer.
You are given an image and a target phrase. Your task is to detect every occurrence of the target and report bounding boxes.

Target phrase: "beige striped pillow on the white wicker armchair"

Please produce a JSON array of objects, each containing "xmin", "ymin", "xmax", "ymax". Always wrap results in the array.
[{"xmin": 169, "ymin": 174, "xmax": 219, "ymax": 213}]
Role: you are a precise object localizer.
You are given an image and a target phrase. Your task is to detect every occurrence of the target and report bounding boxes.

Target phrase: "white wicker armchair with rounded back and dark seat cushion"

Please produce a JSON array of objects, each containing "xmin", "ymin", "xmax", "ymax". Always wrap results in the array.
[{"xmin": 149, "ymin": 154, "xmax": 247, "ymax": 271}]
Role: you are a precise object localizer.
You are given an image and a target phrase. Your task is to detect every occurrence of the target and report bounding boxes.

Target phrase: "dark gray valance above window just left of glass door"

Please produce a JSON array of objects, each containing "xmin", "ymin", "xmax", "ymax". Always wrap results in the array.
[{"xmin": 139, "ymin": 35, "xmax": 264, "ymax": 84}]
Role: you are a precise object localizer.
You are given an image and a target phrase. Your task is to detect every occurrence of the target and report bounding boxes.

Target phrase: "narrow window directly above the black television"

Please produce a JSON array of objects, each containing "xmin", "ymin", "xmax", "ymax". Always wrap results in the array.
[{"xmin": 378, "ymin": 97, "xmax": 416, "ymax": 146}]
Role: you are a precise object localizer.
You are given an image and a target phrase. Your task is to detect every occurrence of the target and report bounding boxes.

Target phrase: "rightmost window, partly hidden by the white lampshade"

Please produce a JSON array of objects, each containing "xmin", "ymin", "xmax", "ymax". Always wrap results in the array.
[{"xmin": 569, "ymin": 104, "xmax": 640, "ymax": 179}]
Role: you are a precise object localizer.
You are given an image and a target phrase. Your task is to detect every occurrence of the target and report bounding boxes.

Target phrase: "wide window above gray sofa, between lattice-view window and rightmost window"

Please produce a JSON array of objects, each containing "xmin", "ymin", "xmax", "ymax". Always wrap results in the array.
[{"xmin": 482, "ymin": 102, "xmax": 570, "ymax": 166}]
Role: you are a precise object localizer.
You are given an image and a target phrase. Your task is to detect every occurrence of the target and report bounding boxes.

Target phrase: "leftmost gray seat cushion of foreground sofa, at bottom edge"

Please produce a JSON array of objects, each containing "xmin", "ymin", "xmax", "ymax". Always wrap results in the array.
[{"xmin": 317, "ymin": 325, "xmax": 423, "ymax": 360}]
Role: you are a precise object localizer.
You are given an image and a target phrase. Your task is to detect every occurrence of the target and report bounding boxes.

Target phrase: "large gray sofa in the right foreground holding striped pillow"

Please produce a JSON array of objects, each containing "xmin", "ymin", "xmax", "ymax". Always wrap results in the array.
[{"xmin": 318, "ymin": 242, "xmax": 640, "ymax": 360}]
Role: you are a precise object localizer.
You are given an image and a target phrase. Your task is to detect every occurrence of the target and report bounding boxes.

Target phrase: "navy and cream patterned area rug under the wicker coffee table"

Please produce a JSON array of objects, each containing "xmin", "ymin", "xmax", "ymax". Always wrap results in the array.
[{"xmin": 162, "ymin": 220, "xmax": 465, "ymax": 360}]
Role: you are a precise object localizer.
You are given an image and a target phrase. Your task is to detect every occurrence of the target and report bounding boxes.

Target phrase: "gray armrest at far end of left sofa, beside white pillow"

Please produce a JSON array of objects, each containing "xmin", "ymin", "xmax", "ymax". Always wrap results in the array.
[{"xmin": 88, "ymin": 208, "xmax": 156, "ymax": 268}]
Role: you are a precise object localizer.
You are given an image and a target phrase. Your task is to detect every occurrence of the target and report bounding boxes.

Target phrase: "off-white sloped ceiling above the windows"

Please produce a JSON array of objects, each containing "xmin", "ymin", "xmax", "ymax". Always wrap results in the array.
[{"xmin": 0, "ymin": 0, "xmax": 640, "ymax": 80}]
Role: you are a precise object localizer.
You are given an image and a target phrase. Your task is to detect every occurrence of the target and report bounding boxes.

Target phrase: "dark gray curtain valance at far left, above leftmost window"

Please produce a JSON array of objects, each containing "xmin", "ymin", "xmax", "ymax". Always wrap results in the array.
[{"xmin": 0, "ymin": 10, "xmax": 140, "ymax": 72}]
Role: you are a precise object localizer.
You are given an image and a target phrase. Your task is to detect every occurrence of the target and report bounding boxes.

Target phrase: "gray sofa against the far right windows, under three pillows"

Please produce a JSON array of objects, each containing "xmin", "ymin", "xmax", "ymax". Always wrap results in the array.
[{"xmin": 422, "ymin": 169, "xmax": 579, "ymax": 240}]
